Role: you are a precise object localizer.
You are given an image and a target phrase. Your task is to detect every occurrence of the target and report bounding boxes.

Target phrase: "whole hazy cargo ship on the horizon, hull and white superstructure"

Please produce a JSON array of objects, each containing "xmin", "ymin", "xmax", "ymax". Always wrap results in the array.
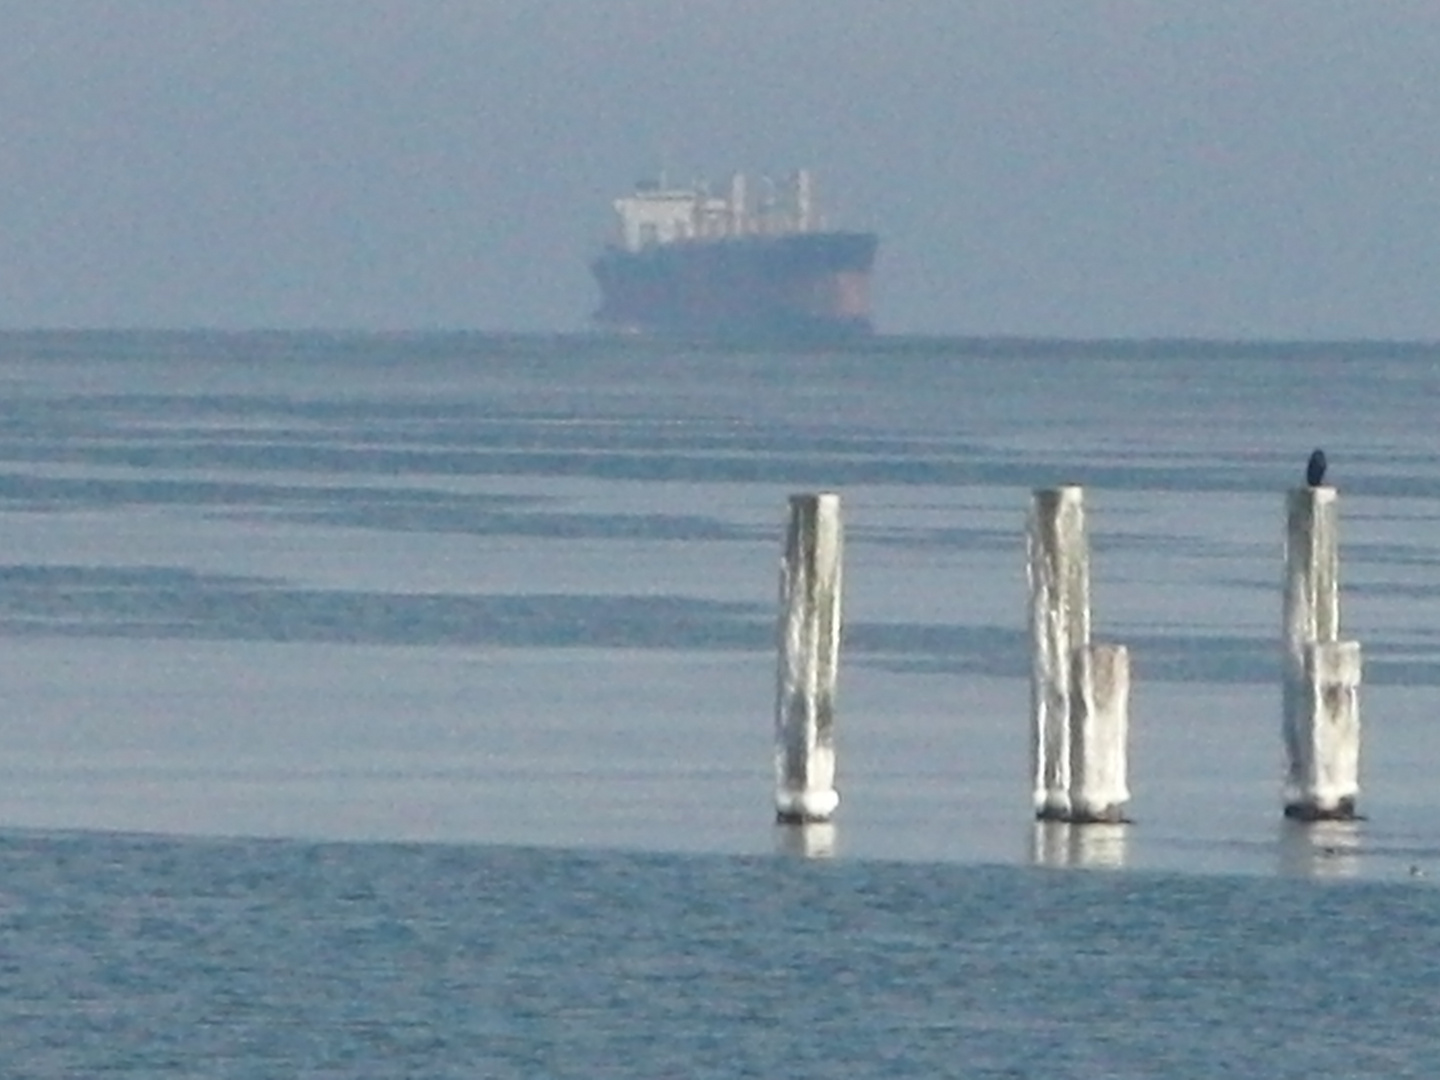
[{"xmin": 590, "ymin": 170, "xmax": 878, "ymax": 340}]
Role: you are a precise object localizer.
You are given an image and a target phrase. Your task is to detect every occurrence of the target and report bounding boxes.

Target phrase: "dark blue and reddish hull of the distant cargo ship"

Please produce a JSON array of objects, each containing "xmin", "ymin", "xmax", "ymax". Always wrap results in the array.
[{"xmin": 592, "ymin": 232, "xmax": 878, "ymax": 340}]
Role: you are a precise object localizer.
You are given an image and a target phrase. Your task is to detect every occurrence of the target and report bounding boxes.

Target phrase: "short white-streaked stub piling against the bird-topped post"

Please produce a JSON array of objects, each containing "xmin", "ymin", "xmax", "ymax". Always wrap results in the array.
[{"xmin": 1284, "ymin": 641, "xmax": 1361, "ymax": 821}]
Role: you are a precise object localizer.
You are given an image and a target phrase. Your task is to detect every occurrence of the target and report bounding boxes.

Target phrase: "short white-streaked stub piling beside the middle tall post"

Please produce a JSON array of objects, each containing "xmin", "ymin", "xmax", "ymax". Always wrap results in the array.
[{"xmin": 1067, "ymin": 645, "xmax": 1130, "ymax": 822}]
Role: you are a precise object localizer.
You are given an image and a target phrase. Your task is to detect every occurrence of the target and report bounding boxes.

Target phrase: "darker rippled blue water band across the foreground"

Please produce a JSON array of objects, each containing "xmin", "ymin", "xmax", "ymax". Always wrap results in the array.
[{"xmin": 0, "ymin": 835, "xmax": 1440, "ymax": 1077}]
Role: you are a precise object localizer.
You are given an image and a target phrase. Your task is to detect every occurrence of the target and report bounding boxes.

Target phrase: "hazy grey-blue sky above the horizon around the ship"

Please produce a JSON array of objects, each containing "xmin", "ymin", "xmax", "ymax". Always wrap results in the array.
[{"xmin": 0, "ymin": 0, "xmax": 1440, "ymax": 340}]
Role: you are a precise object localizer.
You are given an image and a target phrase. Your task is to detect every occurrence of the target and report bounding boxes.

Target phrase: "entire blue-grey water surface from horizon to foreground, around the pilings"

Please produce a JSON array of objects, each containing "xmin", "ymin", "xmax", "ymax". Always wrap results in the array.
[{"xmin": 0, "ymin": 333, "xmax": 1440, "ymax": 1077}]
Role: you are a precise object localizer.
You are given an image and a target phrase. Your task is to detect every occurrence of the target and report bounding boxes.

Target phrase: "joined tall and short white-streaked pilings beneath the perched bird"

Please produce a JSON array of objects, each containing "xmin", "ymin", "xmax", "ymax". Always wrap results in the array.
[{"xmin": 1282, "ymin": 487, "xmax": 1361, "ymax": 821}]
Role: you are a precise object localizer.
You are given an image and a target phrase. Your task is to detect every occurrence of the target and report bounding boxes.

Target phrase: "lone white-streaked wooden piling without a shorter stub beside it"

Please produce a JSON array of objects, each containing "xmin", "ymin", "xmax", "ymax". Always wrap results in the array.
[{"xmin": 775, "ymin": 494, "xmax": 844, "ymax": 822}]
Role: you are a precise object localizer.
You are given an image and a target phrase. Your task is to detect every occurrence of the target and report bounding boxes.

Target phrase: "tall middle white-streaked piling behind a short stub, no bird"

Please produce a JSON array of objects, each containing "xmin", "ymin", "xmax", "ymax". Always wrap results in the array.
[{"xmin": 1027, "ymin": 485, "xmax": 1090, "ymax": 819}]
